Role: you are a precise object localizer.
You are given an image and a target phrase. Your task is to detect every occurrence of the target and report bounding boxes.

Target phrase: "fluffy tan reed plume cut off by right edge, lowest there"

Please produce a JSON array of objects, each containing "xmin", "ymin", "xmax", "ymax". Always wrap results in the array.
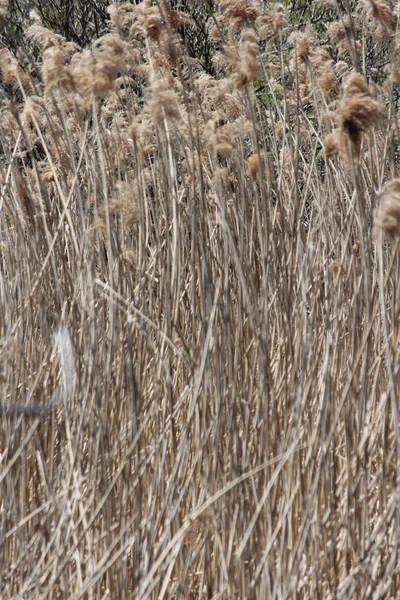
[{"xmin": 374, "ymin": 179, "xmax": 400, "ymax": 240}]
